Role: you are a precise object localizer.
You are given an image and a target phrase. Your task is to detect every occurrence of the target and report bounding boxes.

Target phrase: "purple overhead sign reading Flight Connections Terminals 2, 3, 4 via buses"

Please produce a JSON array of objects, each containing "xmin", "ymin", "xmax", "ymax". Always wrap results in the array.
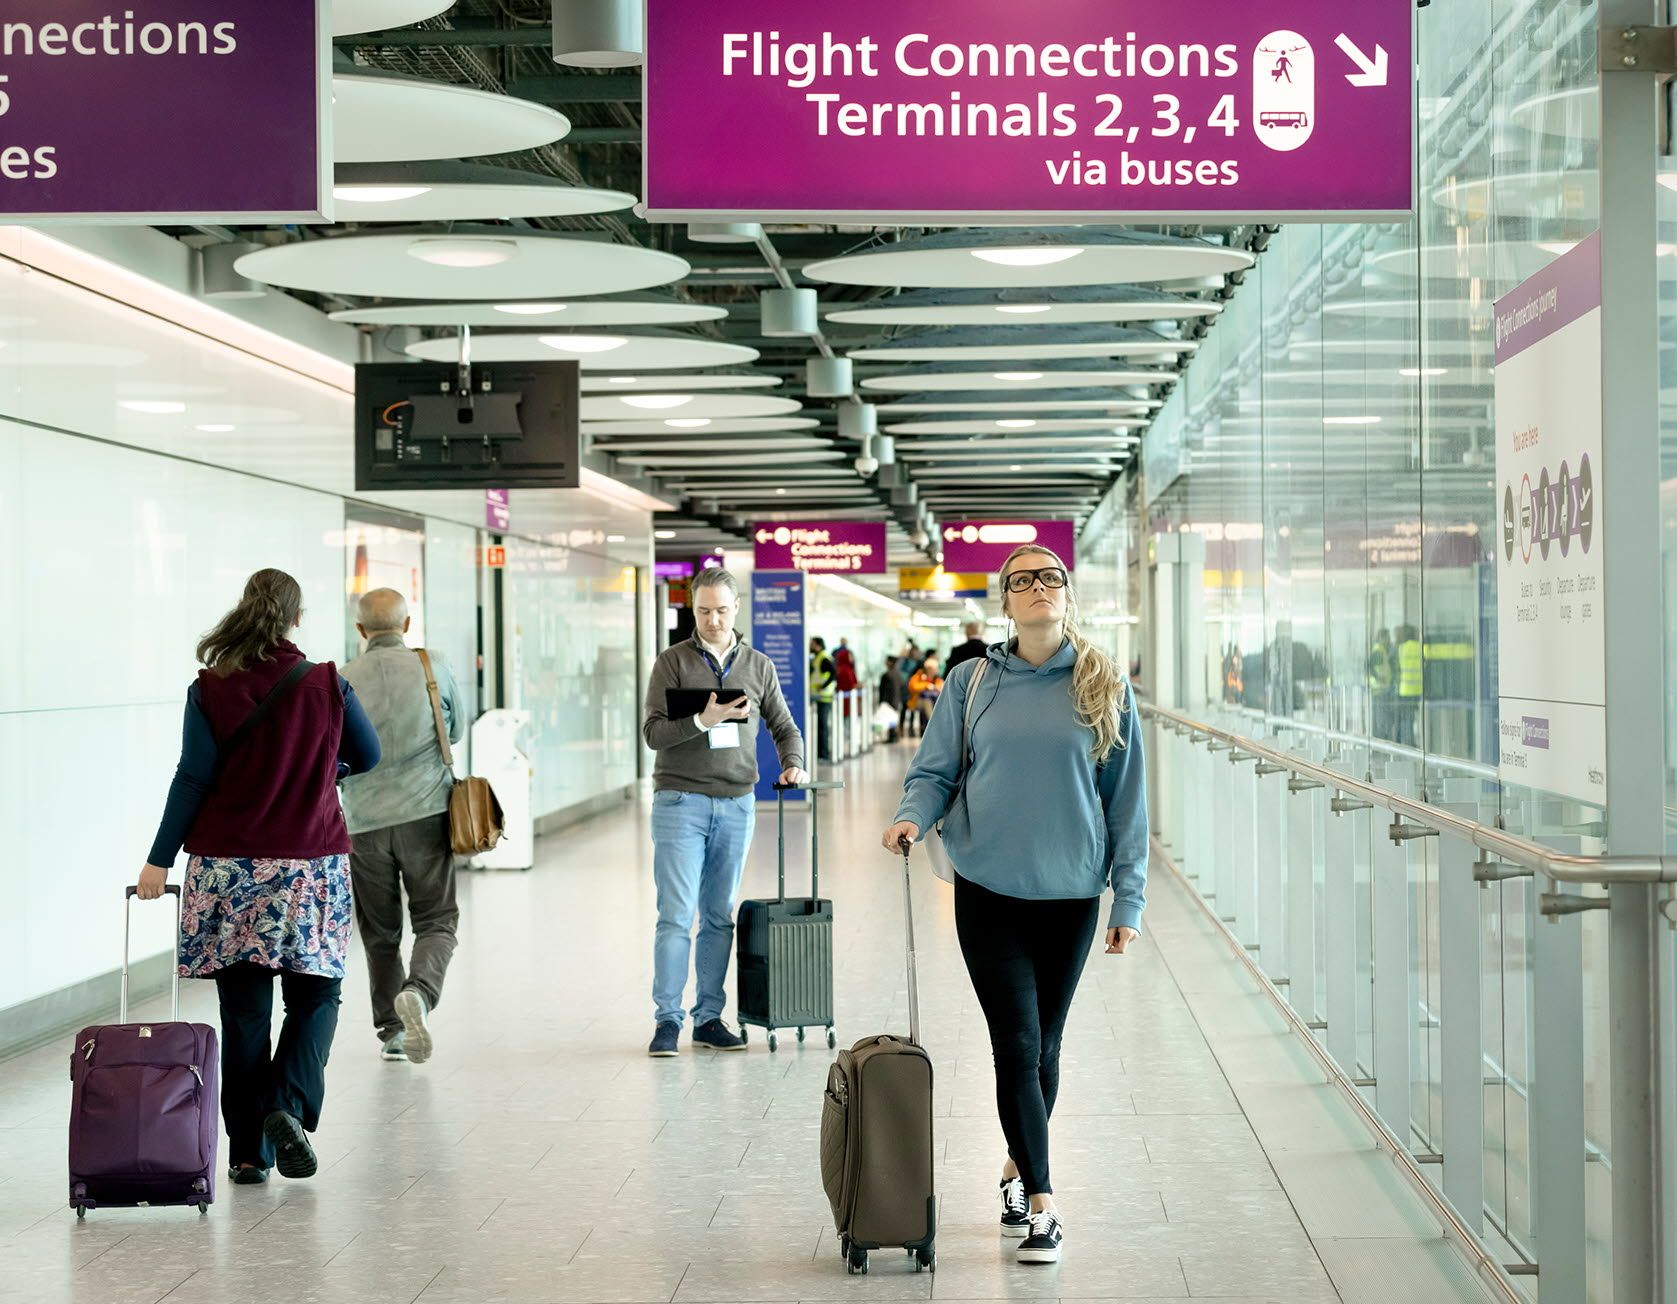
[{"xmin": 644, "ymin": 0, "xmax": 1414, "ymax": 223}]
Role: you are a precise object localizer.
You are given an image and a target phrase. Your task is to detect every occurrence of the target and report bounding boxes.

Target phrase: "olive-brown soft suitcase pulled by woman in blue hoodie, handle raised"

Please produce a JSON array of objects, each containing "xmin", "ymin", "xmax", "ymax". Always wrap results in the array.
[{"xmin": 820, "ymin": 834, "xmax": 937, "ymax": 1272}]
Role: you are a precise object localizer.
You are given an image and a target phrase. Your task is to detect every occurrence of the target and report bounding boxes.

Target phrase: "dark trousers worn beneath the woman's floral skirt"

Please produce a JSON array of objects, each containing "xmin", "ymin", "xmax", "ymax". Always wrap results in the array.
[{"xmin": 215, "ymin": 964, "xmax": 344, "ymax": 1168}]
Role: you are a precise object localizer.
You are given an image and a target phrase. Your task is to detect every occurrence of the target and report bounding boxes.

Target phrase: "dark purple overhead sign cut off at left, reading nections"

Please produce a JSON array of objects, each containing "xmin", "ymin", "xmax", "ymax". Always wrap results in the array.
[{"xmin": 0, "ymin": 0, "xmax": 332, "ymax": 223}]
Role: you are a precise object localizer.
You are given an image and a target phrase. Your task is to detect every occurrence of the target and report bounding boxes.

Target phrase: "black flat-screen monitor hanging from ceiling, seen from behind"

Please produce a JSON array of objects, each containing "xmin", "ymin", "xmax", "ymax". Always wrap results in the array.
[{"xmin": 356, "ymin": 362, "xmax": 582, "ymax": 489}]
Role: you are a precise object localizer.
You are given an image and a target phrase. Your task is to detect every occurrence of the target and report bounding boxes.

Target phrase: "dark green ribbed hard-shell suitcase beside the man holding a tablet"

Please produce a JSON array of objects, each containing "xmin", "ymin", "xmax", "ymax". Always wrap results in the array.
[{"xmin": 736, "ymin": 781, "xmax": 844, "ymax": 1051}]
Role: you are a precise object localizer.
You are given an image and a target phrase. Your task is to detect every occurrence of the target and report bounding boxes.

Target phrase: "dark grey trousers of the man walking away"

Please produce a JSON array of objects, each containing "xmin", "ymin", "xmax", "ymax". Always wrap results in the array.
[{"xmin": 349, "ymin": 813, "xmax": 459, "ymax": 1041}]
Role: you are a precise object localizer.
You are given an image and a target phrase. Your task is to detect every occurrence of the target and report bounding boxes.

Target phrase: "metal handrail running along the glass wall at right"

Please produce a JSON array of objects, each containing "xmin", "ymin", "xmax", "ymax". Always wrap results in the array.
[{"xmin": 1139, "ymin": 702, "xmax": 1677, "ymax": 885}]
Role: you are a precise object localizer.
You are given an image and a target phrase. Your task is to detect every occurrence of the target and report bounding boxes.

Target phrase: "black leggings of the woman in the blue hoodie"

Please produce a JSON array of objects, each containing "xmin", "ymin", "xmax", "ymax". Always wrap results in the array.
[{"xmin": 954, "ymin": 877, "xmax": 1100, "ymax": 1195}]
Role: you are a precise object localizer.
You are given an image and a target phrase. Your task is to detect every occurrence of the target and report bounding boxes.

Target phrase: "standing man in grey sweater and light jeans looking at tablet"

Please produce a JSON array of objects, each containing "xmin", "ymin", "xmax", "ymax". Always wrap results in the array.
[{"xmin": 641, "ymin": 570, "xmax": 808, "ymax": 1056}]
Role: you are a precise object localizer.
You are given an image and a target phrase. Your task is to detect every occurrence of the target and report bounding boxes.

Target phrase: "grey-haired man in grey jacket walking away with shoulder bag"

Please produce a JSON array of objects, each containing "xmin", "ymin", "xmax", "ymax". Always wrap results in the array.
[{"xmin": 342, "ymin": 588, "xmax": 466, "ymax": 1064}]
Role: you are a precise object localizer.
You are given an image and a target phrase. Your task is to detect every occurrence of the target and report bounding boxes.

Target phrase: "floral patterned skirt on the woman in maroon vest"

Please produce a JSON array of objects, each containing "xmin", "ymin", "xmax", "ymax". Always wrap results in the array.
[{"xmin": 181, "ymin": 856, "xmax": 352, "ymax": 977}]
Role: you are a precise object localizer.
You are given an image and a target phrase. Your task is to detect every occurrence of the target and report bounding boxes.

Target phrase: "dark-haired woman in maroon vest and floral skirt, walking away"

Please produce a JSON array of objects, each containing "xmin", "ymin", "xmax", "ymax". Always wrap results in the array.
[{"xmin": 138, "ymin": 570, "xmax": 379, "ymax": 1185}]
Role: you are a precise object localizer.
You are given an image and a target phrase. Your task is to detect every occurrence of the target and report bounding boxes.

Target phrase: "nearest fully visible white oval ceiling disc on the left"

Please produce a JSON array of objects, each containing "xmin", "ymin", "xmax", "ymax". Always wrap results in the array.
[{"xmin": 233, "ymin": 226, "xmax": 689, "ymax": 300}]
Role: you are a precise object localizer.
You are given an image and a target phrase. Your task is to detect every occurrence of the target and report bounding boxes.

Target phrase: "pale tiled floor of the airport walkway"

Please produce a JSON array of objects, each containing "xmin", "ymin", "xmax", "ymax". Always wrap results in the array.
[{"xmin": 0, "ymin": 748, "xmax": 1481, "ymax": 1304}]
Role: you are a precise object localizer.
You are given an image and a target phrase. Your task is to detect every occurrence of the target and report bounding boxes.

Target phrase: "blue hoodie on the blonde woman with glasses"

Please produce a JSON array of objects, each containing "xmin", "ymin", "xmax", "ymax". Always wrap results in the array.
[{"xmin": 897, "ymin": 642, "xmax": 1147, "ymax": 929}]
